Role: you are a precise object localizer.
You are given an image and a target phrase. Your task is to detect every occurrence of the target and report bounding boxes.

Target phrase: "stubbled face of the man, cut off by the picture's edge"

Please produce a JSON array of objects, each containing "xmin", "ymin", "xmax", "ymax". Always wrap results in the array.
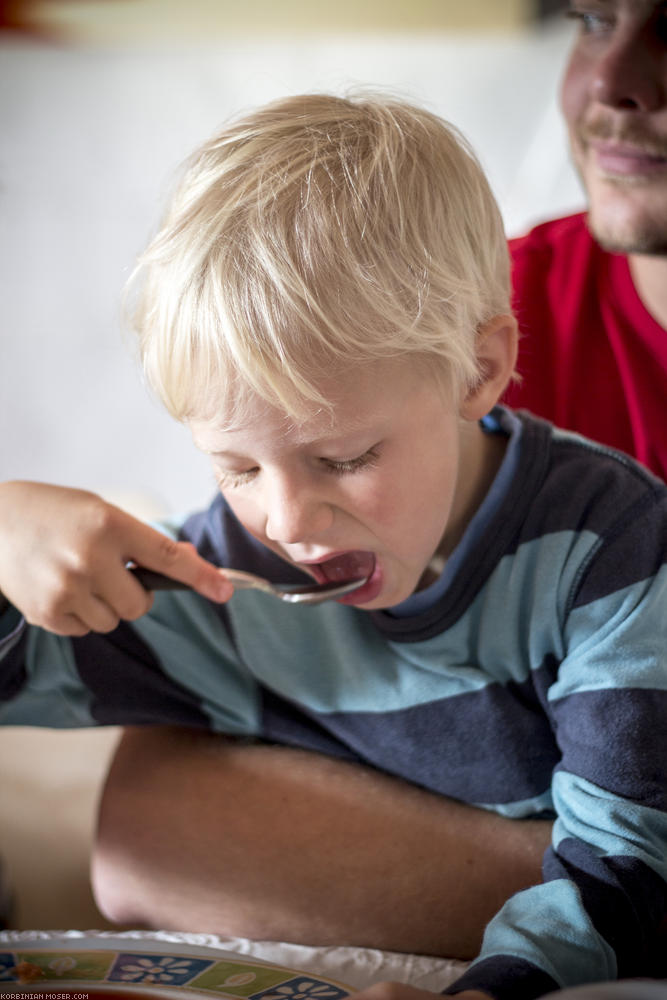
[{"xmin": 561, "ymin": 0, "xmax": 667, "ymax": 254}]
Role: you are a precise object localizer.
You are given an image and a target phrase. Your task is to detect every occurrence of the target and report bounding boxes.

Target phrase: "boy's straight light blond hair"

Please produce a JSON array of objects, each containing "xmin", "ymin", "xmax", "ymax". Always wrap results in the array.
[{"xmin": 135, "ymin": 94, "xmax": 510, "ymax": 420}]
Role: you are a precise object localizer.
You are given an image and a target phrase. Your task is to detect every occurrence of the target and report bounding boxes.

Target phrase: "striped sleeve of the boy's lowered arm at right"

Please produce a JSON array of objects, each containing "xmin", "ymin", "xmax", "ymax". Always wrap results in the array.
[{"xmin": 446, "ymin": 474, "xmax": 667, "ymax": 1000}]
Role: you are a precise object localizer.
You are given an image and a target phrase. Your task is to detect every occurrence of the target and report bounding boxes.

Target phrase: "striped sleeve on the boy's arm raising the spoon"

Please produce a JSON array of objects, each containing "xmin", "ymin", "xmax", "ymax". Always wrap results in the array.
[{"xmin": 0, "ymin": 580, "xmax": 258, "ymax": 735}]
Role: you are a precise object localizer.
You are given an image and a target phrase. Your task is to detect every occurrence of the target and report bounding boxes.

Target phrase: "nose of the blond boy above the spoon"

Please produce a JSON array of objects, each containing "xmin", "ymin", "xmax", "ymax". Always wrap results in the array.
[{"xmin": 265, "ymin": 474, "xmax": 334, "ymax": 545}]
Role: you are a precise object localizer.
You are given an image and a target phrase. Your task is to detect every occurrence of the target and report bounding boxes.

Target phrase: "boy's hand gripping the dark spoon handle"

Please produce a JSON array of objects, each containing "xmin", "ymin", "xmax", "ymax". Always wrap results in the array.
[{"xmin": 0, "ymin": 482, "xmax": 233, "ymax": 636}]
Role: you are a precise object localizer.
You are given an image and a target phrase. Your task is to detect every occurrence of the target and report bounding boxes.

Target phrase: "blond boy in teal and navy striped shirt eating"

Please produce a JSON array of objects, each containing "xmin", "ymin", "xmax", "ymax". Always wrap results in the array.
[{"xmin": 0, "ymin": 95, "xmax": 667, "ymax": 1000}]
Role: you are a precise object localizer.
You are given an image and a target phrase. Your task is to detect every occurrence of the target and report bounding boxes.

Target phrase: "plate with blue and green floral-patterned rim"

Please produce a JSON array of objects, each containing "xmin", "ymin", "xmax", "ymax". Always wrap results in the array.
[{"xmin": 0, "ymin": 937, "xmax": 352, "ymax": 1000}]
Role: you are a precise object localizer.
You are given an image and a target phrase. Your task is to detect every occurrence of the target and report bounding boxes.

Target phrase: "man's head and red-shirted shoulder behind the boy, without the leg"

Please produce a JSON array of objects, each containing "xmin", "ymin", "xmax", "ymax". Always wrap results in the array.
[{"xmin": 509, "ymin": 0, "xmax": 667, "ymax": 478}]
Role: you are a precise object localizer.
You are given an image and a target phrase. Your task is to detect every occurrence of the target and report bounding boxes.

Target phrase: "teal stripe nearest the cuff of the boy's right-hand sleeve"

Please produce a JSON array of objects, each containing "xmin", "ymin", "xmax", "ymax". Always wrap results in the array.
[{"xmin": 473, "ymin": 879, "xmax": 617, "ymax": 988}]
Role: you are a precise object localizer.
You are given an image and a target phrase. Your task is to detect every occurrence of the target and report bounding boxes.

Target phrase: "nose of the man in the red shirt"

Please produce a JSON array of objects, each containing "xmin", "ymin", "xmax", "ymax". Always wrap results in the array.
[{"xmin": 591, "ymin": 25, "xmax": 667, "ymax": 111}]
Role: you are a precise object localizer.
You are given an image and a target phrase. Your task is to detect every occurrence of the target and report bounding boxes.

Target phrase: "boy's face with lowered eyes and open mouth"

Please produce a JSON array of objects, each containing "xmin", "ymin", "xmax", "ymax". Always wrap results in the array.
[{"xmin": 190, "ymin": 361, "xmax": 494, "ymax": 610}]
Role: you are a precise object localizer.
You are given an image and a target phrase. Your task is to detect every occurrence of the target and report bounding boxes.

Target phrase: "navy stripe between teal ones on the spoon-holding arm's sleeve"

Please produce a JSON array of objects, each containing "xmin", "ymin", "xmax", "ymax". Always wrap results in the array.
[{"xmin": 72, "ymin": 622, "xmax": 210, "ymax": 728}]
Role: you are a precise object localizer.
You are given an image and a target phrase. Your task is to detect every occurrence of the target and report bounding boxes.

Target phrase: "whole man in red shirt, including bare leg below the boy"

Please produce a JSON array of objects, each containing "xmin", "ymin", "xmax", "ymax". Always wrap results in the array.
[{"xmin": 94, "ymin": 0, "xmax": 667, "ymax": 958}]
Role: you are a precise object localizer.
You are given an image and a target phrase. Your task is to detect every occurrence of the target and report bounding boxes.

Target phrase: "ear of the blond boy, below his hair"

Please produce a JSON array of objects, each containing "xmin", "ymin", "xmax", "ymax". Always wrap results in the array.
[{"xmin": 460, "ymin": 314, "xmax": 519, "ymax": 420}]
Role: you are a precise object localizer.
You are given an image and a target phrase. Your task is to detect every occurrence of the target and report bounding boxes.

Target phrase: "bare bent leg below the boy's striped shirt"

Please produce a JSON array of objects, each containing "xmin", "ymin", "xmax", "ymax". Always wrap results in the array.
[{"xmin": 93, "ymin": 728, "xmax": 551, "ymax": 958}]
